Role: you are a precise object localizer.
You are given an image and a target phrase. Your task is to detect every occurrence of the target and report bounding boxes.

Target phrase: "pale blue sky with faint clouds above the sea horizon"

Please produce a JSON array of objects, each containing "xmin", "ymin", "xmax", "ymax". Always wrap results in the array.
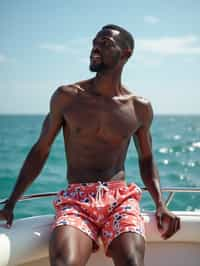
[{"xmin": 0, "ymin": 0, "xmax": 200, "ymax": 114}]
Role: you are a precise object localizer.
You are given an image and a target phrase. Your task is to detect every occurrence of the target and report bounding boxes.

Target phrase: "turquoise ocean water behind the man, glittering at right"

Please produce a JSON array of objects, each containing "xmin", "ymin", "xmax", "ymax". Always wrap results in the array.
[{"xmin": 0, "ymin": 115, "xmax": 200, "ymax": 218}]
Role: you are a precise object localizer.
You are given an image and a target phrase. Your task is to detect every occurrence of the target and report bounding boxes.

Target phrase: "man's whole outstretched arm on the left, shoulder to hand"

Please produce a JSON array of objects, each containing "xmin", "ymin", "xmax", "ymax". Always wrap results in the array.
[{"xmin": 0, "ymin": 89, "xmax": 66, "ymax": 226}]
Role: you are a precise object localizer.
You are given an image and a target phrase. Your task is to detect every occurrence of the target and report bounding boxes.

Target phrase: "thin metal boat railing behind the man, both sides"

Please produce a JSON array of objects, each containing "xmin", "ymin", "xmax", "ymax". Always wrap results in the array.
[{"xmin": 0, "ymin": 187, "xmax": 200, "ymax": 206}]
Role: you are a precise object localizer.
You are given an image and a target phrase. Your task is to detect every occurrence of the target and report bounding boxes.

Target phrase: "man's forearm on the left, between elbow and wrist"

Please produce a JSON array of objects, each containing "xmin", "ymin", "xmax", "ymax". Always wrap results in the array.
[{"xmin": 6, "ymin": 144, "xmax": 48, "ymax": 209}]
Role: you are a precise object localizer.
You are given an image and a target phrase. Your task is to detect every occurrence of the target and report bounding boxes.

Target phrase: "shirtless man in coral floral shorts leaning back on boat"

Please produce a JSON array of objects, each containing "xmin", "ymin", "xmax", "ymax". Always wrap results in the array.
[{"xmin": 0, "ymin": 25, "xmax": 180, "ymax": 266}]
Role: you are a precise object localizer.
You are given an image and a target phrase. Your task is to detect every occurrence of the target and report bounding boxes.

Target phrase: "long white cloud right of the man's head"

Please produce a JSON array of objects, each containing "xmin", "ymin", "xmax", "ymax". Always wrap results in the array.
[{"xmin": 136, "ymin": 35, "xmax": 200, "ymax": 55}]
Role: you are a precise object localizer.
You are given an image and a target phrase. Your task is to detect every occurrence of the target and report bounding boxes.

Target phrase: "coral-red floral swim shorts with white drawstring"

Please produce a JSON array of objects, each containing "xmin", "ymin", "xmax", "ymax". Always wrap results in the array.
[{"xmin": 53, "ymin": 181, "xmax": 145, "ymax": 256}]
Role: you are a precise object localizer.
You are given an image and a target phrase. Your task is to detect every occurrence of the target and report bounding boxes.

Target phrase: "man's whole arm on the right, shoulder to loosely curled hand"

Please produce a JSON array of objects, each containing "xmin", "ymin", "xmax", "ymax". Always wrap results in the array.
[{"xmin": 133, "ymin": 99, "xmax": 180, "ymax": 239}]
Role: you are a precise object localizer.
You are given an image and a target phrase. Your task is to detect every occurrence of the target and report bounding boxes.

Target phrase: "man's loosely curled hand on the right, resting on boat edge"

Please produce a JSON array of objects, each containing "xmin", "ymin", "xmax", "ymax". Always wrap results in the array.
[{"xmin": 156, "ymin": 206, "xmax": 180, "ymax": 239}]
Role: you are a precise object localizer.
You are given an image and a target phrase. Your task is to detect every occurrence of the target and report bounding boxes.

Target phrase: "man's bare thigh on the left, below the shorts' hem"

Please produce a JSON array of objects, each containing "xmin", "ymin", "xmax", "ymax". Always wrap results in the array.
[{"xmin": 49, "ymin": 225, "xmax": 93, "ymax": 266}]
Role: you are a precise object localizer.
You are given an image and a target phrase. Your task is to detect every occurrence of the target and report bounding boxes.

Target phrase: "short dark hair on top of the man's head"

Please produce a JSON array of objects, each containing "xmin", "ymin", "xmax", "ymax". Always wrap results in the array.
[{"xmin": 102, "ymin": 24, "xmax": 135, "ymax": 51}]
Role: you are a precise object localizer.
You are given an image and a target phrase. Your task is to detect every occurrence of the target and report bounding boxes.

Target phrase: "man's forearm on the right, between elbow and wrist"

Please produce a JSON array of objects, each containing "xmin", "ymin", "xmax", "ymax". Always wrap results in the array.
[{"xmin": 139, "ymin": 157, "xmax": 164, "ymax": 207}]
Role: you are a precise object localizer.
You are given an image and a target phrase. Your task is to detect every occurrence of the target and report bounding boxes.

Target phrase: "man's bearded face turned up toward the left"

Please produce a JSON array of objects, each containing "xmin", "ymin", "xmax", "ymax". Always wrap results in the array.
[{"xmin": 90, "ymin": 29, "xmax": 122, "ymax": 72}]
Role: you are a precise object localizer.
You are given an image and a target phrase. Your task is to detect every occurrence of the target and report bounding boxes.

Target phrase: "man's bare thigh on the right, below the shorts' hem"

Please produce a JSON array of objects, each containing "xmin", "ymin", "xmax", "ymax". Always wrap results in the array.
[{"xmin": 108, "ymin": 232, "xmax": 145, "ymax": 266}]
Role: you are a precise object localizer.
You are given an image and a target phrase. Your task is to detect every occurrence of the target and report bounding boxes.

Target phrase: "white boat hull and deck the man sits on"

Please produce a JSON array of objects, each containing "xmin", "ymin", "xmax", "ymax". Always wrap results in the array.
[{"xmin": 0, "ymin": 189, "xmax": 200, "ymax": 266}]
